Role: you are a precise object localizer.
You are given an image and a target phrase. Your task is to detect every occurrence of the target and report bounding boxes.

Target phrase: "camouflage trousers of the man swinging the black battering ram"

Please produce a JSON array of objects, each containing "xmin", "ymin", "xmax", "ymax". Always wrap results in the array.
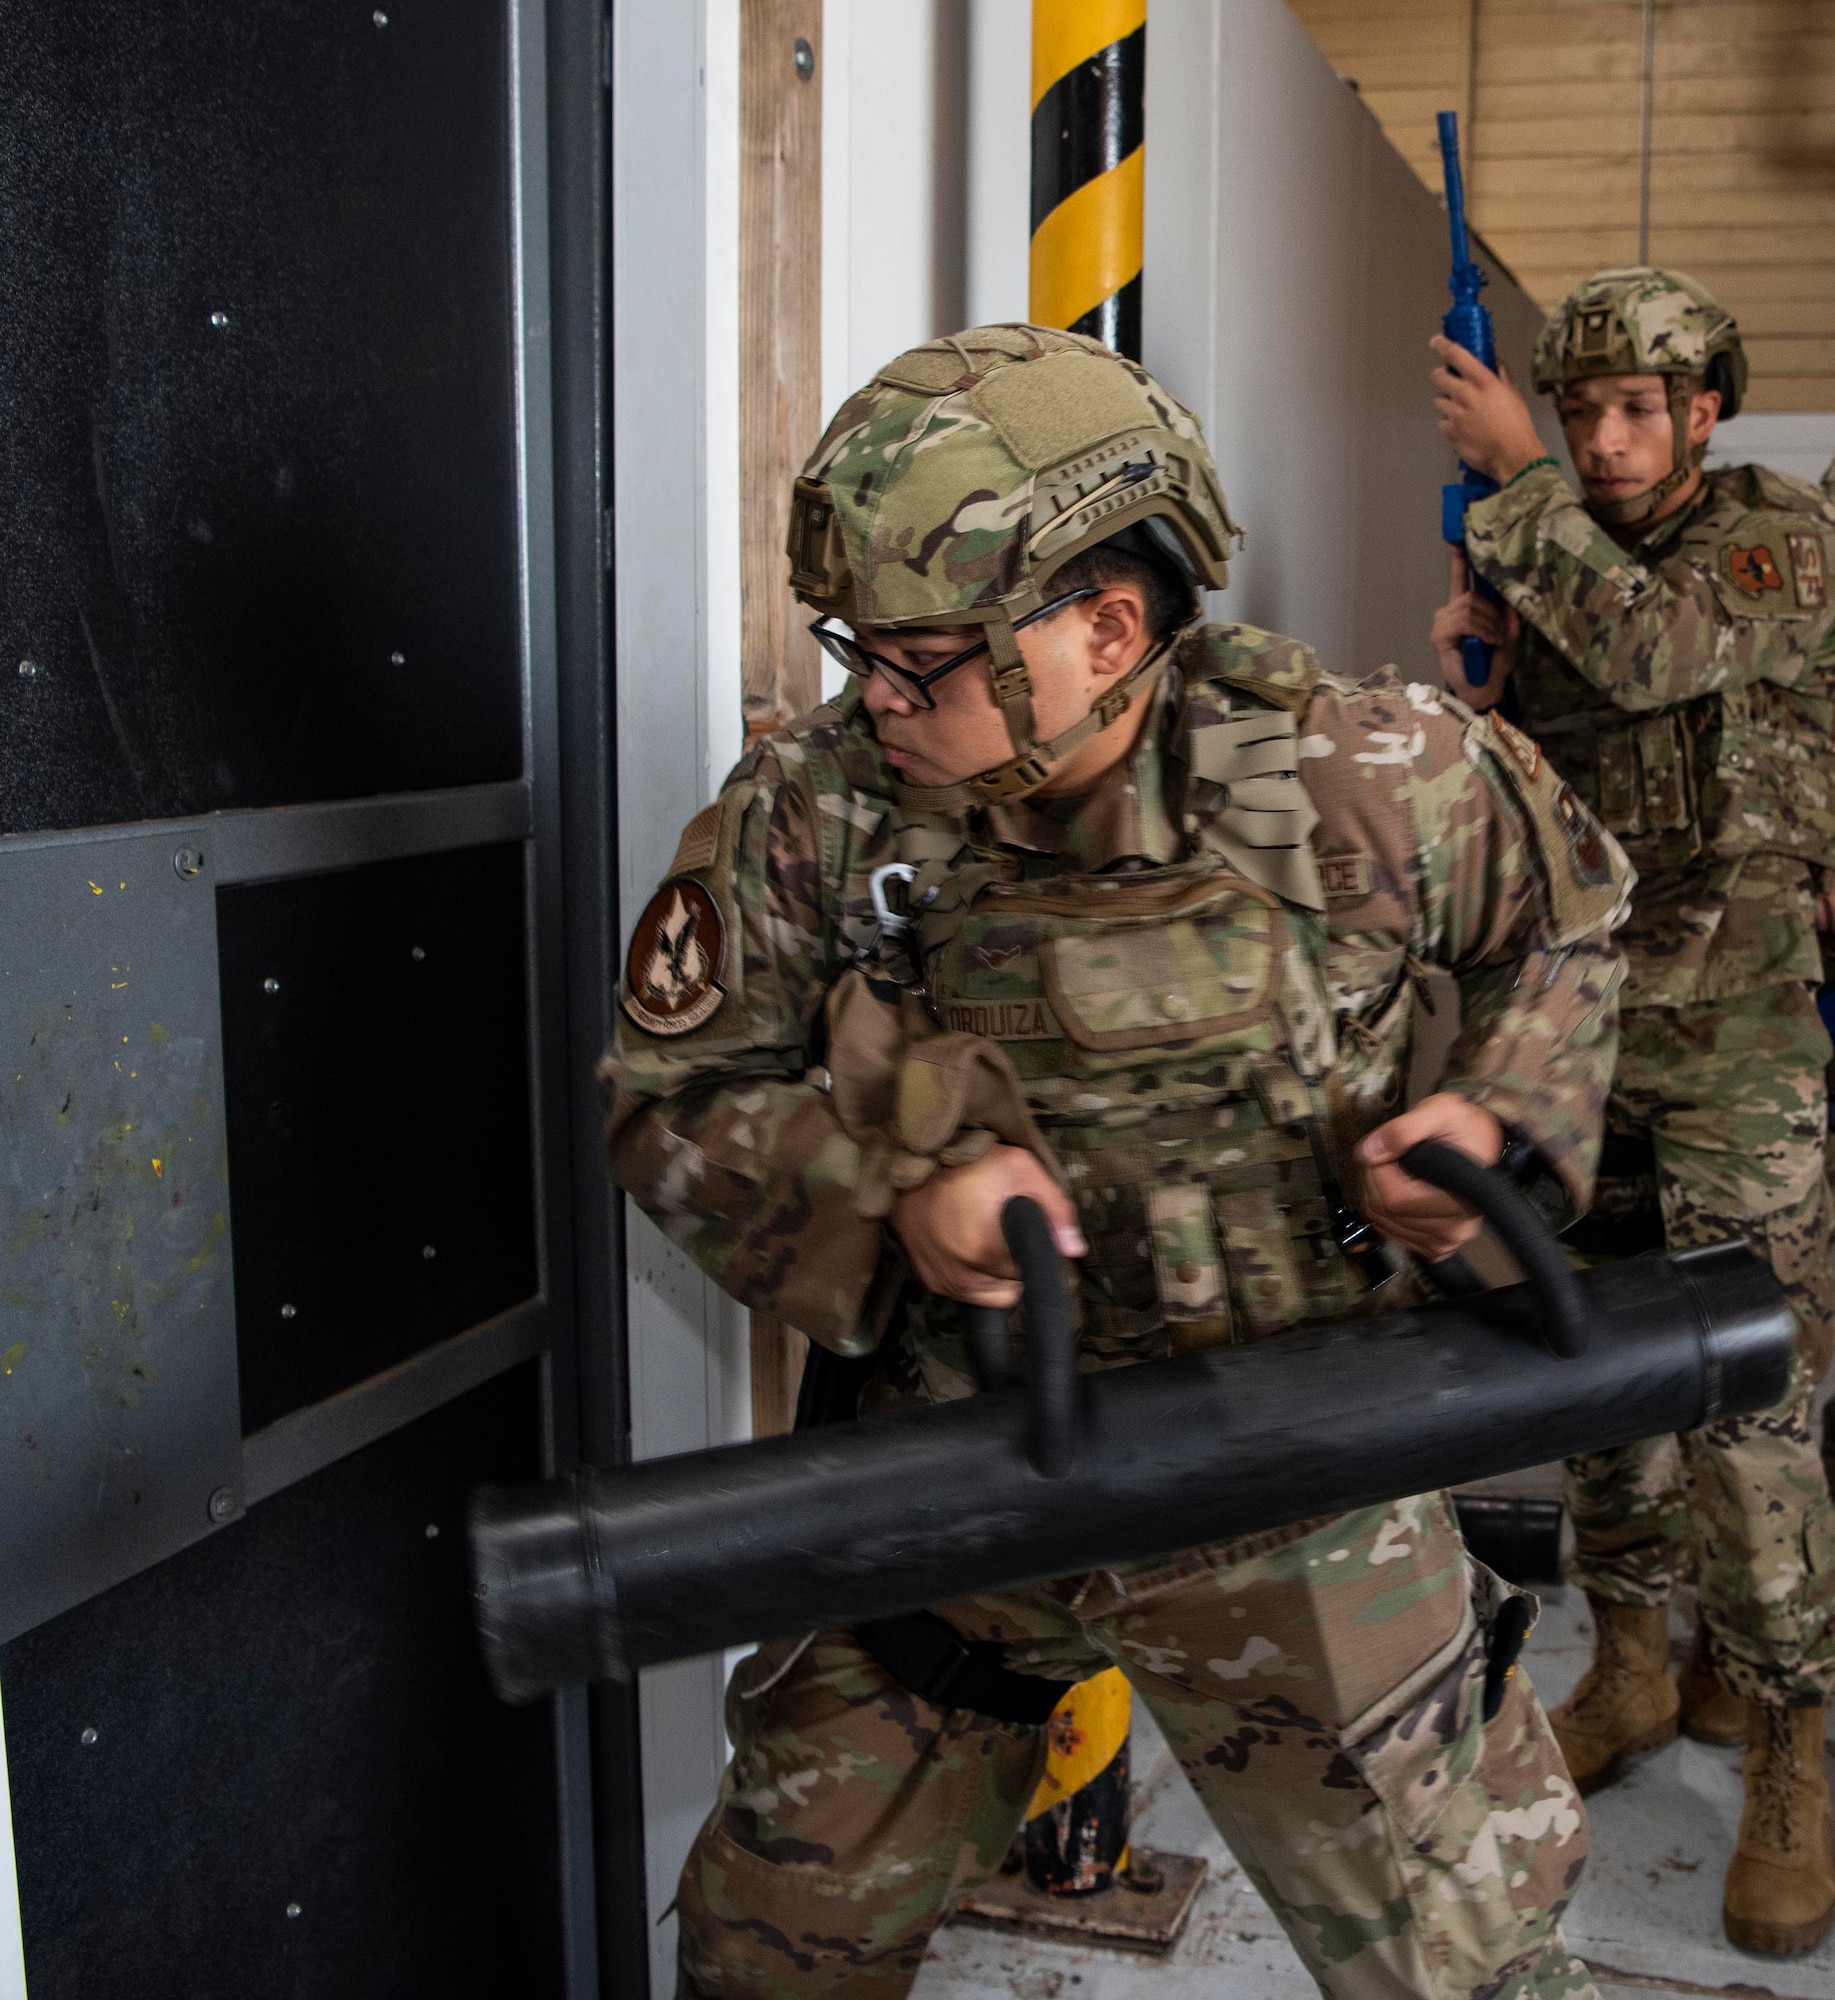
[{"xmin": 678, "ymin": 1496, "xmax": 1593, "ymax": 2000}]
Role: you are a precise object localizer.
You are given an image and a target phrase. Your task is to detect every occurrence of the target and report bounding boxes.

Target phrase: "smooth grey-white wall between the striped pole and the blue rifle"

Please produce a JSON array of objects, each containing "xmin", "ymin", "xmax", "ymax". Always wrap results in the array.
[{"xmin": 1141, "ymin": 0, "xmax": 1559, "ymax": 674}]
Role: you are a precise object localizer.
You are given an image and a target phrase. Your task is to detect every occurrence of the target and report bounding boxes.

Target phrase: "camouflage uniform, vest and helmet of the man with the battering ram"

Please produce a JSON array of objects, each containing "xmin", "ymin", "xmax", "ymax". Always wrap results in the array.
[{"xmin": 604, "ymin": 326, "xmax": 1629, "ymax": 2000}]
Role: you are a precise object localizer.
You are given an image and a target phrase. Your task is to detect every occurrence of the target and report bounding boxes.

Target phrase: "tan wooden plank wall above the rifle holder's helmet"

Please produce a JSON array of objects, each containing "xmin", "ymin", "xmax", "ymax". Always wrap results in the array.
[{"xmin": 1291, "ymin": 0, "xmax": 1835, "ymax": 410}]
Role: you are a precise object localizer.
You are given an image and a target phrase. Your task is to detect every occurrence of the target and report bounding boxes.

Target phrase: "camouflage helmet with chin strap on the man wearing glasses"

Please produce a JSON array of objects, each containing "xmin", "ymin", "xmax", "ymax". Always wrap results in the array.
[{"xmin": 790, "ymin": 326, "xmax": 1241, "ymax": 812}]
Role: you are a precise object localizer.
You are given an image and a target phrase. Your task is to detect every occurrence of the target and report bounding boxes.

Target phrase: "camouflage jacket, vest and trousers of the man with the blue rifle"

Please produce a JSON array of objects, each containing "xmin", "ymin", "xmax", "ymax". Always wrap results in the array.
[{"xmin": 1467, "ymin": 464, "xmax": 1835, "ymax": 1706}]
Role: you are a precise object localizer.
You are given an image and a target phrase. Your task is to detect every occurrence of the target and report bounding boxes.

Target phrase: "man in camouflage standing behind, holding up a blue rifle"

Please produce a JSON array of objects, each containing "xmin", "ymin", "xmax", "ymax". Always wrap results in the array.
[{"xmin": 1433, "ymin": 266, "xmax": 1835, "ymax": 1956}]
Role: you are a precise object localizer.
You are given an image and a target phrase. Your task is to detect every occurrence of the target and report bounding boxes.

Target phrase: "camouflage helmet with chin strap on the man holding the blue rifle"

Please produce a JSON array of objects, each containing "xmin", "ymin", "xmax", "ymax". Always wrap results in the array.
[{"xmin": 1533, "ymin": 264, "xmax": 1745, "ymax": 526}]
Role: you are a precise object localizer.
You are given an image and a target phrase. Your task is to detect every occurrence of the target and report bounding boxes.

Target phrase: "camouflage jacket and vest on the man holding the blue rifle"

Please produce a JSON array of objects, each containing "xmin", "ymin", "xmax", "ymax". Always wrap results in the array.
[{"xmin": 1465, "ymin": 466, "xmax": 1835, "ymax": 1006}]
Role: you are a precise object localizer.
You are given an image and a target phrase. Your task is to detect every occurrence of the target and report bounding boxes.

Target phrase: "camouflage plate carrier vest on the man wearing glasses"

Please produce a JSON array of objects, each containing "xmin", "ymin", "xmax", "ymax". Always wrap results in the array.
[{"xmin": 848, "ymin": 640, "xmax": 1367, "ymax": 1366}]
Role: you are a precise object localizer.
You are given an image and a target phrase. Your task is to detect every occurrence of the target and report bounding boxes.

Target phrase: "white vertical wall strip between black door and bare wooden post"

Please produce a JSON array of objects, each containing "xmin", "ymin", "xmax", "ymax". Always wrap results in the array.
[{"xmin": 612, "ymin": 0, "xmax": 752, "ymax": 1994}]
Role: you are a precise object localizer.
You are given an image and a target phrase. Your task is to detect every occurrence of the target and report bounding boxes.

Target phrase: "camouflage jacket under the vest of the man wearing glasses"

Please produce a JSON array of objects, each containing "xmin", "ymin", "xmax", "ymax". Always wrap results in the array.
[{"xmin": 600, "ymin": 626, "xmax": 1629, "ymax": 1358}]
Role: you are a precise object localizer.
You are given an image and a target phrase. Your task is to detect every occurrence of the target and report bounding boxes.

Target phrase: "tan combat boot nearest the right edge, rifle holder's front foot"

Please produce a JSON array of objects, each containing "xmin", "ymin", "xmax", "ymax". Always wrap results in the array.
[{"xmin": 1725, "ymin": 1702, "xmax": 1835, "ymax": 1958}]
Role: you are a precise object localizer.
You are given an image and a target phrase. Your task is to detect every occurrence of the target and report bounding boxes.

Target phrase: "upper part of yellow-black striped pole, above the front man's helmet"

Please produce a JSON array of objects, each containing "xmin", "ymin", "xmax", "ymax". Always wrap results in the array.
[{"xmin": 1029, "ymin": 0, "xmax": 1147, "ymax": 360}]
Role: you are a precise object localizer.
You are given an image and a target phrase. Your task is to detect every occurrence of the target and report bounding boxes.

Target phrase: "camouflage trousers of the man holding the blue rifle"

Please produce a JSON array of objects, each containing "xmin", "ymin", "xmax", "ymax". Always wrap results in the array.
[{"xmin": 1567, "ymin": 984, "xmax": 1835, "ymax": 1706}]
